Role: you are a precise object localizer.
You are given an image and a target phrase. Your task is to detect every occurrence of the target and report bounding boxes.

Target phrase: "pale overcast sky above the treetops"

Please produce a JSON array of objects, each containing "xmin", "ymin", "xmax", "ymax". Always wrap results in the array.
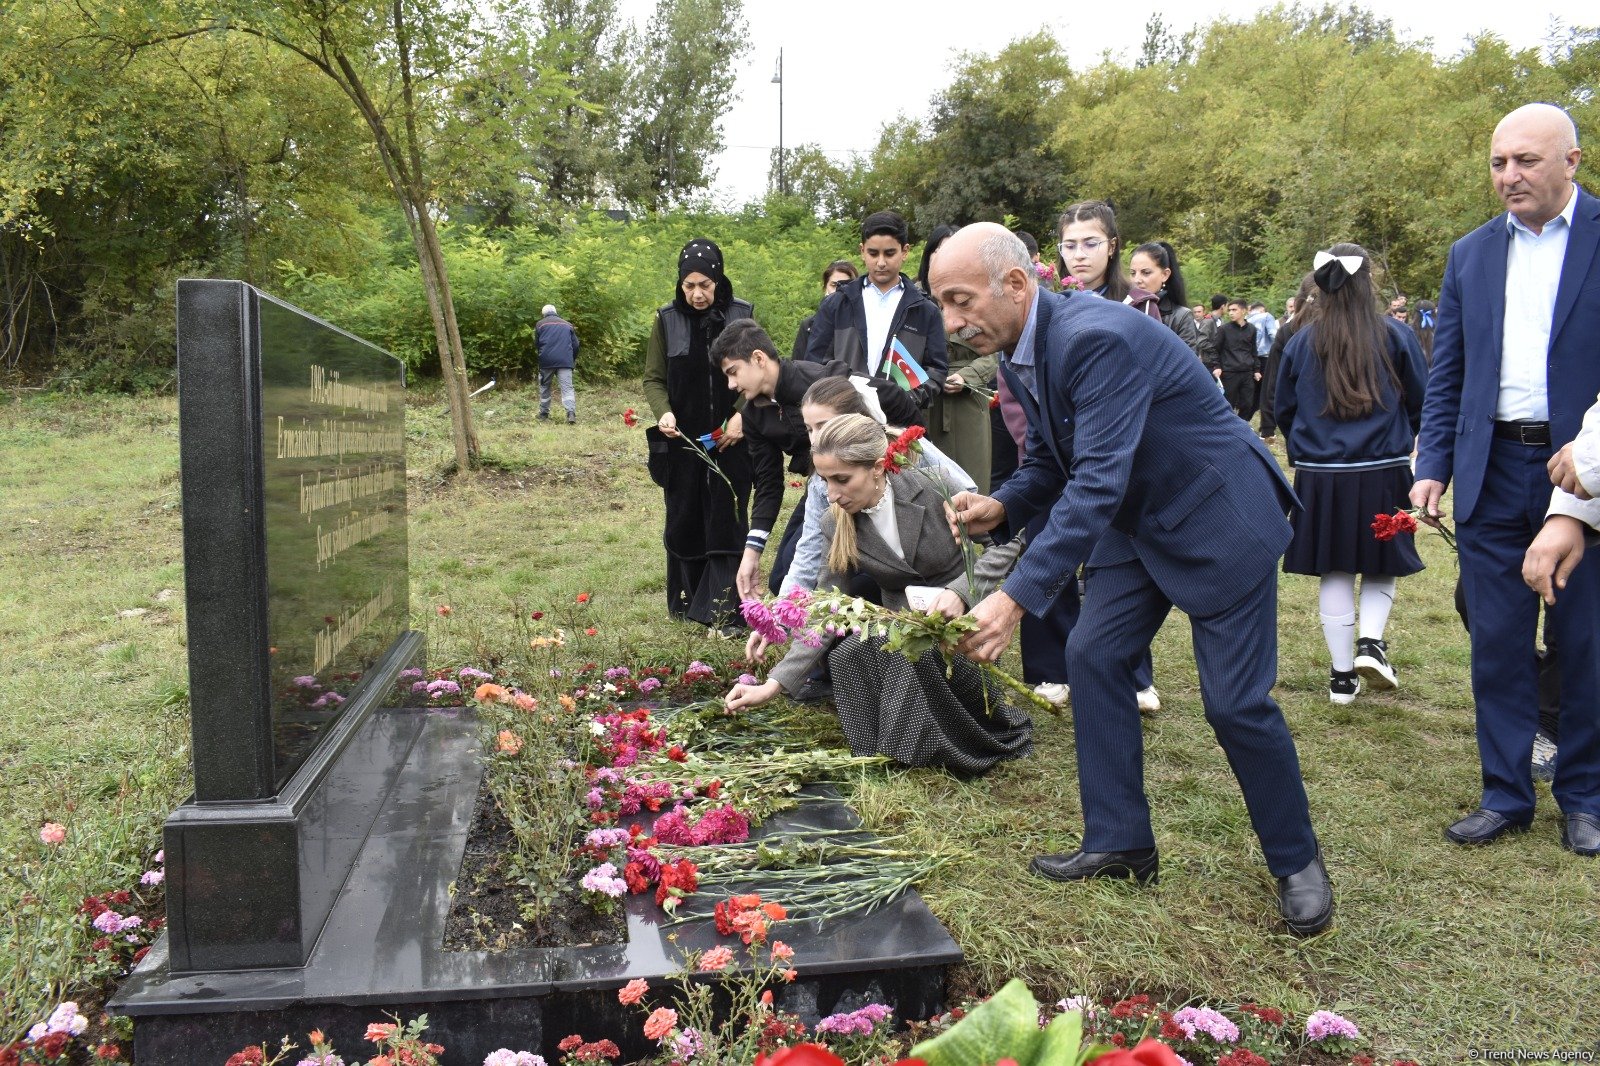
[{"xmin": 621, "ymin": 0, "xmax": 1592, "ymax": 206}]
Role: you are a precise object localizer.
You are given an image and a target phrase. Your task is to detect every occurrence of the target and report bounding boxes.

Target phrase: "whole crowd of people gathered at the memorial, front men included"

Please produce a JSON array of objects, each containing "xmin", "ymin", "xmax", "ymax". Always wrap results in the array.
[{"xmin": 601, "ymin": 104, "xmax": 1600, "ymax": 933}]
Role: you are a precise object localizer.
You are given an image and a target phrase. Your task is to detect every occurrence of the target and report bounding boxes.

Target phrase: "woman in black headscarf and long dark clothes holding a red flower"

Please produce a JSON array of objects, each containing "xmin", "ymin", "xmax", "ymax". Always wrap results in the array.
[{"xmin": 645, "ymin": 240, "xmax": 752, "ymax": 626}]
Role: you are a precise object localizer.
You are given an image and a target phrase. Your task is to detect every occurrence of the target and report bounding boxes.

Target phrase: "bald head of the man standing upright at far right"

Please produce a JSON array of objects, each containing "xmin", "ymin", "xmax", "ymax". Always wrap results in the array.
[{"xmin": 1490, "ymin": 104, "xmax": 1582, "ymax": 232}]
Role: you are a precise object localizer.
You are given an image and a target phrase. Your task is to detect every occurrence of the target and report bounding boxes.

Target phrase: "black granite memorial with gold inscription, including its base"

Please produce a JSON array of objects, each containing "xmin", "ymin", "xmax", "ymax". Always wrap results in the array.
[{"xmin": 118, "ymin": 282, "xmax": 962, "ymax": 1066}]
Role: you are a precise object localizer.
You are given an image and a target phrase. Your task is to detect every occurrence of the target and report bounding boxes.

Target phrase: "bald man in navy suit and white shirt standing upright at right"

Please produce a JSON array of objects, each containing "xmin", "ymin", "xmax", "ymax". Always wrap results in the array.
[{"xmin": 1411, "ymin": 104, "xmax": 1600, "ymax": 856}]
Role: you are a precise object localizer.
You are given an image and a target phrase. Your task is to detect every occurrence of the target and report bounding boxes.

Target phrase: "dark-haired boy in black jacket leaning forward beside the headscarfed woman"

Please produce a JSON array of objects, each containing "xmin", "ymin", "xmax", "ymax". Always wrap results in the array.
[{"xmin": 710, "ymin": 319, "xmax": 944, "ymax": 599}]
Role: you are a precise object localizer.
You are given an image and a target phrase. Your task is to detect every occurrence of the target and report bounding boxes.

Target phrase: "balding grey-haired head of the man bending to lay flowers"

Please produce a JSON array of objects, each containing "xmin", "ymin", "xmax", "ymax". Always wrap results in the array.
[{"xmin": 928, "ymin": 222, "xmax": 1038, "ymax": 355}]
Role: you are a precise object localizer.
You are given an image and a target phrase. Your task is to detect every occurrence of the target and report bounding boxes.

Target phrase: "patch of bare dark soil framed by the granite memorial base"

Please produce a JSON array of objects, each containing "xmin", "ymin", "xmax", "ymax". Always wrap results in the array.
[{"xmin": 445, "ymin": 789, "xmax": 627, "ymax": 951}]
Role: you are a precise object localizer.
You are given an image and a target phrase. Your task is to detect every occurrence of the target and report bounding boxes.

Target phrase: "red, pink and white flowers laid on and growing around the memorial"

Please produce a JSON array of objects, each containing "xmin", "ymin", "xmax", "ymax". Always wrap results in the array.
[{"xmin": 15, "ymin": 605, "xmax": 1427, "ymax": 1066}]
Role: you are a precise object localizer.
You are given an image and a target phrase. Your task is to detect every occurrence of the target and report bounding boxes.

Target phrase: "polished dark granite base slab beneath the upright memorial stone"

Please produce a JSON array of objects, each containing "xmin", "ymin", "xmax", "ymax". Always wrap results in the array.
[{"xmin": 109, "ymin": 709, "xmax": 962, "ymax": 1066}]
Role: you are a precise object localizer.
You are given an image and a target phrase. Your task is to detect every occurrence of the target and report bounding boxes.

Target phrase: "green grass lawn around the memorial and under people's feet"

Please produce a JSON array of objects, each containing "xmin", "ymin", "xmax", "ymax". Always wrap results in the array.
[{"xmin": 0, "ymin": 391, "xmax": 1600, "ymax": 1063}]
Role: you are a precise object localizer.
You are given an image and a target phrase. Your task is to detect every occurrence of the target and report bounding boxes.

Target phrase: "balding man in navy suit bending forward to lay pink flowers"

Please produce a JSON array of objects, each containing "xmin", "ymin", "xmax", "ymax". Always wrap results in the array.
[{"xmin": 930, "ymin": 222, "xmax": 1333, "ymax": 935}]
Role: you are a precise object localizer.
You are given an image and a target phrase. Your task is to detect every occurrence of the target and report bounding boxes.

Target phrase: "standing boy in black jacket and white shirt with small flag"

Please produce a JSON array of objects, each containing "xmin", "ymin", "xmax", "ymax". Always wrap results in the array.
[{"xmin": 805, "ymin": 211, "xmax": 950, "ymax": 407}]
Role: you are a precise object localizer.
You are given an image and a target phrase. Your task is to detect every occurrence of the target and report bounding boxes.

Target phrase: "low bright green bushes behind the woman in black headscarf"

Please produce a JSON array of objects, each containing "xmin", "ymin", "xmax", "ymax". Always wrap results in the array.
[{"xmin": 280, "ymin": 209, "xmax": 856, "ymax": 381}]
